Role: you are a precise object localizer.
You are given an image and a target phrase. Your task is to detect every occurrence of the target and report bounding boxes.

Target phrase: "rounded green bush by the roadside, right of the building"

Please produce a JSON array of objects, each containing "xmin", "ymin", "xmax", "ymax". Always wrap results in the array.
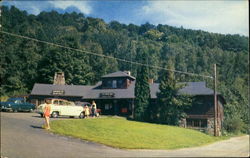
[{"xmin": 223, "ymin": 117, "xmax": 247, "ymax": 134}]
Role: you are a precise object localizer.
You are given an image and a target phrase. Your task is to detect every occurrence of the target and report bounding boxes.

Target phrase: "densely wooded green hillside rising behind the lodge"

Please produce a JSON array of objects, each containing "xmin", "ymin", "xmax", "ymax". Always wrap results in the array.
[{"xmin": 0, "ymin": 6, "xmax": 249, "ymax": 125}]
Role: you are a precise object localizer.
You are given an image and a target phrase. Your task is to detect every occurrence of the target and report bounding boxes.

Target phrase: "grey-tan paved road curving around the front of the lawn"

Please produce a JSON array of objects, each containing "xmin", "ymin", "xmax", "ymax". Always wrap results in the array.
[{"xmin": 1, "ymin": 112, "xmax": 249, "ymax": 158}]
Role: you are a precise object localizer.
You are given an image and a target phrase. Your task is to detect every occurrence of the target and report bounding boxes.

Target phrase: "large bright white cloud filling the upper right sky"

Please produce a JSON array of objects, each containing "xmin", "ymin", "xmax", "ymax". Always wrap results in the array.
[{"xmin": 139, "ymin": 1, "xmax": 249, "ymax": 35}]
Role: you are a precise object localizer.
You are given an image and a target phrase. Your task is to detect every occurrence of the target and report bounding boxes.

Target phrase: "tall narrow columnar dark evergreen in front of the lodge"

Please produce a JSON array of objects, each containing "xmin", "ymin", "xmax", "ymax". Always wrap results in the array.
[{"xmin": 134, "ymin": 48, "xmax": 150, "ymax": 121}]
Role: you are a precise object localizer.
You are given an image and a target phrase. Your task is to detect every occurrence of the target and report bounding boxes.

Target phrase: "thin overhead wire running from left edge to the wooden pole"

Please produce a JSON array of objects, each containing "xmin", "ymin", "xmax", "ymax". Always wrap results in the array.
[{"xmin": 0, "ymin": 31, "xmax": 213, "ymax": 78}]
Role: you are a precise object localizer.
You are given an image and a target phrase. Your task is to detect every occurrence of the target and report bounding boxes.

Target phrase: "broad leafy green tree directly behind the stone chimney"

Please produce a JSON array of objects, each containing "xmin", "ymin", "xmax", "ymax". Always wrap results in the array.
[{"xmin": 36, "ymin": 49, "xmax": 93, "ymax": 85}]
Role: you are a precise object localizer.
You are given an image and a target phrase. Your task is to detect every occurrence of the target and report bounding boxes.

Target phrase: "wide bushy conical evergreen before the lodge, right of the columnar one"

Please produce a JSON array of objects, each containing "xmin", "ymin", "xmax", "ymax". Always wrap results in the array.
[{"xmin": 155, "ymin": 60, "xmax": 191, "ymax": 125}]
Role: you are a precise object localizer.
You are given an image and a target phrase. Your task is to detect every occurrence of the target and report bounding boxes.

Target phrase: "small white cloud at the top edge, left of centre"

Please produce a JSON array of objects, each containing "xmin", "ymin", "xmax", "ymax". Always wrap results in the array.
[{"xmin": 49, "ymin": 1, "xmax": 92, "ymax": 14}]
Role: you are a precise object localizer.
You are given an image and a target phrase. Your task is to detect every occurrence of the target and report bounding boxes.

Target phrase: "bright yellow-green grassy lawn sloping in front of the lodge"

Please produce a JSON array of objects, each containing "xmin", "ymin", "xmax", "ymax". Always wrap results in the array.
[{"xmin": 51, "ymin": 117, "xmax": 223, "ymax": 149}]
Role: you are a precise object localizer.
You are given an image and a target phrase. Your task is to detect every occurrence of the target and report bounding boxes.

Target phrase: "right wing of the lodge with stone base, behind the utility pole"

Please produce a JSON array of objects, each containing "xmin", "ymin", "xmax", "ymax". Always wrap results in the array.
[{"xmin": 179, "ymin": 82, "xmax": 226, "ymax": 135}]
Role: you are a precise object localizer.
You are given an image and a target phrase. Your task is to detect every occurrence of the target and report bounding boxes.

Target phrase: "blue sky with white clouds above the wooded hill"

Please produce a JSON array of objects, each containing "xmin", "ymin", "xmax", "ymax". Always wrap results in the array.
[{"xmin": 2, "ymin": 0, "xmax": 249, "ymax": 36}]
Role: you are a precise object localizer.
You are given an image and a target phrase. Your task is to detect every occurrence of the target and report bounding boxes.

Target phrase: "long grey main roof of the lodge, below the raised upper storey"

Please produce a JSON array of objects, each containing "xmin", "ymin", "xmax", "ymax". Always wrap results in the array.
[{"xmin": 31, "ymin": 78, "xmax": 222, "ymax": 99}]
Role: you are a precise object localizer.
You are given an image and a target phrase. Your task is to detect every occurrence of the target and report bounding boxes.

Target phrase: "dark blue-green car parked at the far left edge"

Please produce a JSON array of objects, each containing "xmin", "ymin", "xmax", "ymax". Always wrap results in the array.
[{"xmin": 1, "ymin": 98, "xmax": 36, "ymax": 112}]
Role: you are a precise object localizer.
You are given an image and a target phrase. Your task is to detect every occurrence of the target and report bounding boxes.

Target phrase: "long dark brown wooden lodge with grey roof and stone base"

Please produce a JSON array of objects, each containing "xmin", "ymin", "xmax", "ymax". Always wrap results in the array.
[{"xmin": 30, "ymin": 71, "xmax": 225, "ymax": 133}]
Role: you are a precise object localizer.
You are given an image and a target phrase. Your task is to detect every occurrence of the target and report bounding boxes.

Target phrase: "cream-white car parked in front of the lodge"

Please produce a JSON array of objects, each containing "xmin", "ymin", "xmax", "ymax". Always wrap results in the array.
[{"xmin": 37, "ymin": 98, "xmax": 84, "ymax": 118}]
